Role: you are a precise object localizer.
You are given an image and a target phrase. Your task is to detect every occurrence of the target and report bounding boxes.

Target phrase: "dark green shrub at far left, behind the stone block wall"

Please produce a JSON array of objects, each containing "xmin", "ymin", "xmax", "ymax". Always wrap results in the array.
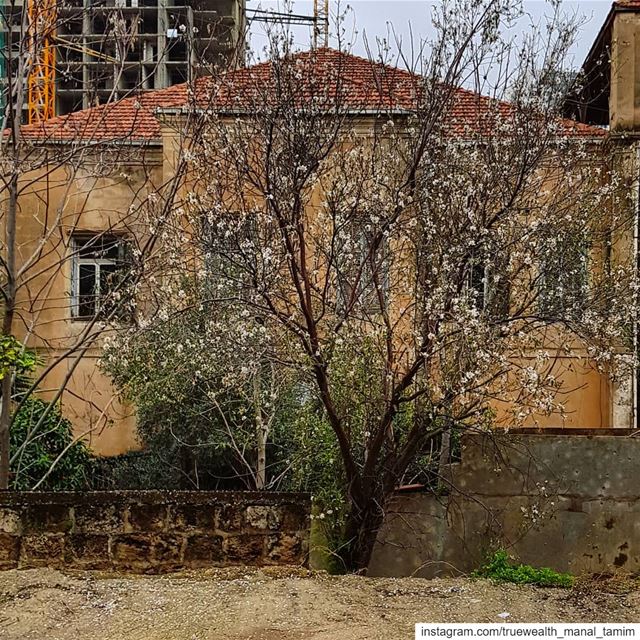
[{"xmin": 10, "ymin": 396, "xmax": 93, "ymax": 491}]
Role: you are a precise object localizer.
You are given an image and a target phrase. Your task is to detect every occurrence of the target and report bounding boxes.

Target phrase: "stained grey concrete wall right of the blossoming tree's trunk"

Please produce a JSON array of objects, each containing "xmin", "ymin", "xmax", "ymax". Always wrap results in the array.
[{"xmin": 370, "ymin": 431, "xmax": 640, "ymax": 577}]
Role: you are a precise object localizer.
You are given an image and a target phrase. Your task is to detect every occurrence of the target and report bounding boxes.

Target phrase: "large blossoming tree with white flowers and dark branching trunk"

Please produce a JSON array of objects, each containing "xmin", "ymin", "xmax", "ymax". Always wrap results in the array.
[{"xmin": 107, "ymin": 0, "xmax": 637, "ymax": 569}]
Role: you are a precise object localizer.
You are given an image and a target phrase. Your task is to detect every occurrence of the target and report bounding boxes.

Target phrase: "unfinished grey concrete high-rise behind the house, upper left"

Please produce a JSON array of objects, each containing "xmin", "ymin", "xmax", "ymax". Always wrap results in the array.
[{"xmin": 0, "ymin": 0, "xmax": 245, "ymax": 115}]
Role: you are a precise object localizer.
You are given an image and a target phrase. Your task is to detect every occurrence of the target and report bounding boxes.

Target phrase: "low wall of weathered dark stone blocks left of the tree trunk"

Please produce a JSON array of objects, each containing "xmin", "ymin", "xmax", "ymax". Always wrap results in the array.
[{"xmin": 0, "ymin": 491, "xmax": 311, "ymax": 573}]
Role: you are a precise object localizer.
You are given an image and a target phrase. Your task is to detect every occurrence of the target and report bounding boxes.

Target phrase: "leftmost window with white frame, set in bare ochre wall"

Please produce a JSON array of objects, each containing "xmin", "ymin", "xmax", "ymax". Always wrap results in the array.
[{"xmin": 71, "ymin": 233, "xmax": 130, "ymax": 318}]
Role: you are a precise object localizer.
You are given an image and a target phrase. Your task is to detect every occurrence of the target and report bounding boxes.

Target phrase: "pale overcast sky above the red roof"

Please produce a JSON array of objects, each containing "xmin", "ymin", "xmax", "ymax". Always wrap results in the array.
[{"xmin": 247, "ymin": 0, "xmax": 612, "ymax": 67}]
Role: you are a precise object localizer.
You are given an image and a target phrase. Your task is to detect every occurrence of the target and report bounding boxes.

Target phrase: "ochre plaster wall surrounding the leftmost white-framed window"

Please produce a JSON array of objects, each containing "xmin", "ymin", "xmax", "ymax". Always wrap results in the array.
[{"xmin": 0, "ymin": 148, "xmax": 162, "ymax": 455}]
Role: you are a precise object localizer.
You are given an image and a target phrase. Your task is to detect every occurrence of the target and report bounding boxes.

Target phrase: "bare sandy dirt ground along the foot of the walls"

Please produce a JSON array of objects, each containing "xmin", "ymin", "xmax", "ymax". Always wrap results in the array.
[{"xmin": 0, "ymin": 568, "xmax": 640, "ymax": 640}]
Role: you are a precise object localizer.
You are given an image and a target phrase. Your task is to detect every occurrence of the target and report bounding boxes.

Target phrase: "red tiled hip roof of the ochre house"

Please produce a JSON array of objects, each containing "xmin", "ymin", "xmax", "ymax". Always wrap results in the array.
[{"xmin": 15, "ymin": 47, "xmax": 604, "ymax": 142}]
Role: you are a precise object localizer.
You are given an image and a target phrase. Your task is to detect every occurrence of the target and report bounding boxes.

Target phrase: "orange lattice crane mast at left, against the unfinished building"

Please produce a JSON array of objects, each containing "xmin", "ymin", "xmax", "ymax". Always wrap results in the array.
[{"xmin": 27, "ymin": 0, "xmax": 57, "ymax": 124}]
